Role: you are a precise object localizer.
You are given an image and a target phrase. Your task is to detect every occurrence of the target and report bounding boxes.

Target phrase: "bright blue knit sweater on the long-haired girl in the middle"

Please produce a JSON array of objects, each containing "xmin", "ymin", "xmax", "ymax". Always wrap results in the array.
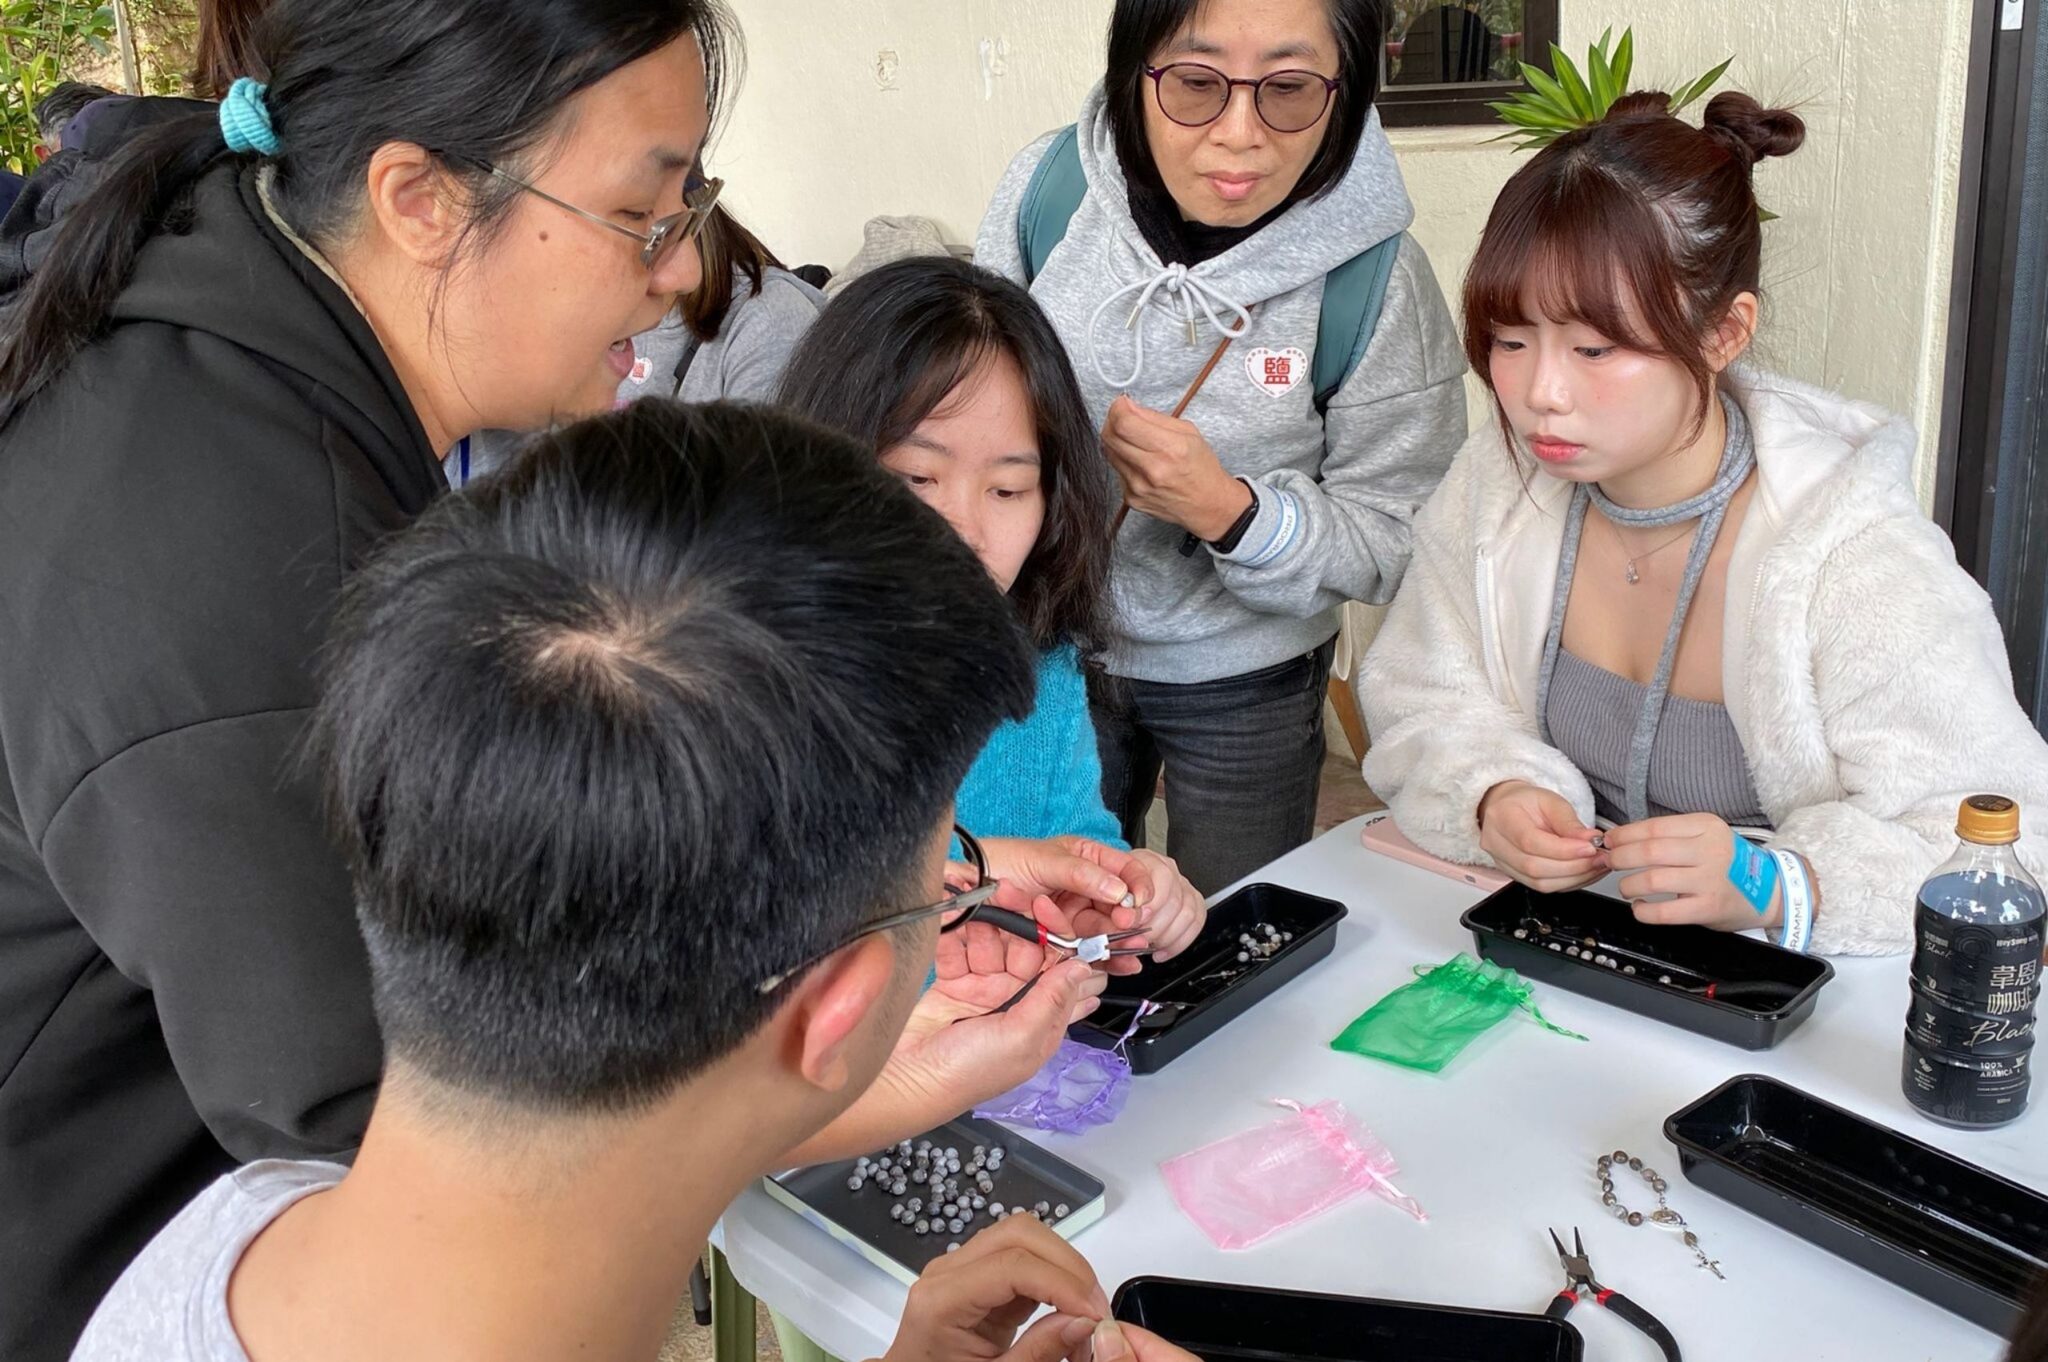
[{"xmin": 954, "ymin": 647, "xmax": 1130, "ymax": 850}]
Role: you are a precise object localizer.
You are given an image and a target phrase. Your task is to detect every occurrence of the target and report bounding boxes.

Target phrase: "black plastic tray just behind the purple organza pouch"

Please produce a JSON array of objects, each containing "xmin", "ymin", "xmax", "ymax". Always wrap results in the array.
[{"xmin": 1067, "ymin": 885, "xmax": 1348, "ymax": 1073}]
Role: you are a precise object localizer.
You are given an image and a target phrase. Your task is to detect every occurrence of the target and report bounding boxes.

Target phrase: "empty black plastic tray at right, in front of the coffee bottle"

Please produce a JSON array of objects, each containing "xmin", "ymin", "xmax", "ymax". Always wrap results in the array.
[{"xmin": 1665, "ymin": 1073, "xmax": 2048, "ymax": 1335}]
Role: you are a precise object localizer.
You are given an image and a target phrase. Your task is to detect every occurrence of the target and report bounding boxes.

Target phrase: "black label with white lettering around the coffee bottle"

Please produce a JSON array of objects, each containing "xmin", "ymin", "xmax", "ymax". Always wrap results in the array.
[{"xmin": 1903, "ymin": 903, "xmax": 2042, "ymax": 1124}]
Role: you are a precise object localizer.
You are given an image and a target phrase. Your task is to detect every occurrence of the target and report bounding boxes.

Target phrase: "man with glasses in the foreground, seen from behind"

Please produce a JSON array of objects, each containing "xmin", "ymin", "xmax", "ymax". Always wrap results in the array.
[{"xmin": 74, "ymin": 403, "xmax": 1192, "ymax": 1362}]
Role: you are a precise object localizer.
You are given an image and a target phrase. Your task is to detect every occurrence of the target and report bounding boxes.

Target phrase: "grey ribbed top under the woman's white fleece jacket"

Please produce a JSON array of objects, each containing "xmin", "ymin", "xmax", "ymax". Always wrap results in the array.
[{"xmin": 1546, "ymin": 649, "xmax": 1769, "ymax": 827}]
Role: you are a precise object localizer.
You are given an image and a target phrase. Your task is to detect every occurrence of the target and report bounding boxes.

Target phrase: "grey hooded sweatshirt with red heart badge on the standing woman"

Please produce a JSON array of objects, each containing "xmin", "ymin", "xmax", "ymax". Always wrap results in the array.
[{"xmin": 975, "ymin": 86, "xmax": 1464, "ymax": 682}]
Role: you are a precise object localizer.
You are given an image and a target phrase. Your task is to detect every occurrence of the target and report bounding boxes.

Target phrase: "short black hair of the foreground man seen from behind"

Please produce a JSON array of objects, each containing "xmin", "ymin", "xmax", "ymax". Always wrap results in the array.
[{"xmin": 313, "ymin": 401, "xmax": 1032, "ymax": 1112}]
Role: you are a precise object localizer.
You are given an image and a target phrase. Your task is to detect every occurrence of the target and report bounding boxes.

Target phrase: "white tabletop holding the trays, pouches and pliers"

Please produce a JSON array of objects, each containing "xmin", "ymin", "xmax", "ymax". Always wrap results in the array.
[{"xmin": 723, "ymin": 819, "xmax": 2048, "ymax": 1362}]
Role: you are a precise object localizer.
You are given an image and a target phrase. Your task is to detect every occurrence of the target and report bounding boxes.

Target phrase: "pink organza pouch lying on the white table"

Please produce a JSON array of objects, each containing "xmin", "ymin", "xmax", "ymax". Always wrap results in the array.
[{"xmin": 1159, "ymin": 1100, "xmax": 1430, "ymax": 1249}]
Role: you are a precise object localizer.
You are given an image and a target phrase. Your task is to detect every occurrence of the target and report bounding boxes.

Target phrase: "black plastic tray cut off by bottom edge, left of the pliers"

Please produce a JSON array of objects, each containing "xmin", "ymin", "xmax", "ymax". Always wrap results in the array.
[{"xmin": 1112, "ymin": 1276, "xmax": 1585, "ymax": 1362}]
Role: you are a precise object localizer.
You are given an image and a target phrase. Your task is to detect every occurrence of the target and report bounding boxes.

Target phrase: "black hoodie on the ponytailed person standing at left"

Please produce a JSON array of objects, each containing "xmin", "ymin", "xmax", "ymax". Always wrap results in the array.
[{"xmin": 0, "ymin": 166, "xmax": 446, "ymax": 1362}]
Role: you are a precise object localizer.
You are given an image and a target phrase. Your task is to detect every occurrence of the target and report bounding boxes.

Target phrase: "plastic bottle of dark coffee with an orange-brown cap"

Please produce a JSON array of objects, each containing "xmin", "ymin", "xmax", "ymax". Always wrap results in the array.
[{"xmin": 1903, "ymin": 795, "xmax": 2044, "ymax": 1129}]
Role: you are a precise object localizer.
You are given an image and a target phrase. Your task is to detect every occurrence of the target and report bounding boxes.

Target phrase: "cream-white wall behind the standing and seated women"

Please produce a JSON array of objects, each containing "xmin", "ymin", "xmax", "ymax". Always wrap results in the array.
[{"xmin": 713, "ymin": 0, "xmax": 1970, "ymax": 498}]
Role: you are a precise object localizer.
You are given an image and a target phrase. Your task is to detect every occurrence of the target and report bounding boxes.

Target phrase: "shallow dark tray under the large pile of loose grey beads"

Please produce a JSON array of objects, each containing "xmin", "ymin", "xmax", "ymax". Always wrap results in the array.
[{"xmin": 766, "ymin": 1116, "xmax": 1104, "ymax": 1282}]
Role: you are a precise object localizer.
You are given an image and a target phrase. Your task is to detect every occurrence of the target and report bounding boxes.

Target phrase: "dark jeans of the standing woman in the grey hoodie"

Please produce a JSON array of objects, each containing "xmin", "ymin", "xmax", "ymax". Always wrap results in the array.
[{"xmin": 1090, "ymin": 639, "xmax": 1337, "ymax": 895}]
